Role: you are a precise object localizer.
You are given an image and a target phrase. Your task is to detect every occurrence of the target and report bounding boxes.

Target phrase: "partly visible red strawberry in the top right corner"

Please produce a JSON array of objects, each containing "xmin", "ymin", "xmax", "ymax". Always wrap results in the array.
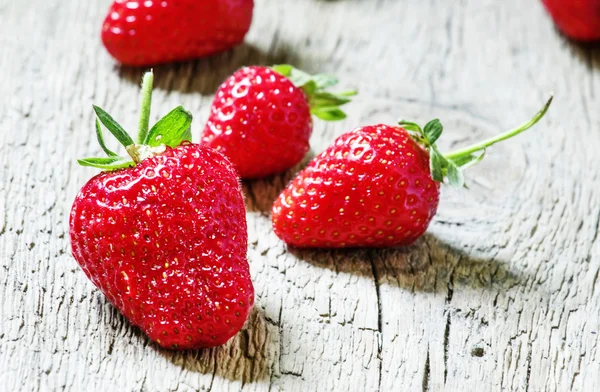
[{"xmin": 543, "ymin": 0, "xmax": 600, "ymax": 41}]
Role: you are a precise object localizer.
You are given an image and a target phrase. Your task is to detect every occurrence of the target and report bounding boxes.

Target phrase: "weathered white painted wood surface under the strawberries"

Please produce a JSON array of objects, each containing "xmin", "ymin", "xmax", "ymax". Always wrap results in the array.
[{"xmin": 0, "ymin": 0, "xmax": 600, "ymax": 391}]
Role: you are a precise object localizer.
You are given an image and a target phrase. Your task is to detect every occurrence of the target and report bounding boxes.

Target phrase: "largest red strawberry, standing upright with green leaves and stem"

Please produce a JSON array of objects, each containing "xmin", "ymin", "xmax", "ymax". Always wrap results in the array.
[{"xmin": 70, "ymin": 74, "xmax": 254, "ymax": 349}]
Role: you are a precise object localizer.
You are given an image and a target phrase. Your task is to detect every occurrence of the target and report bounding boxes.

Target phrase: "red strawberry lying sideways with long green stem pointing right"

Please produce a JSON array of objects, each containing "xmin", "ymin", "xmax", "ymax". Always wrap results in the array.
[{"xmin": 272, "ymin": 99, "xmax": 552, "ymax": 248}]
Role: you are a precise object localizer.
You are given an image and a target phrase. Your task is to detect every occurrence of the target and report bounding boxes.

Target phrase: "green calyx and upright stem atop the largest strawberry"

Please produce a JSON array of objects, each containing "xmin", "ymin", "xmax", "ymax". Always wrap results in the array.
[{"xmin": 77, "ymin": 71, "xmax": 192, "ymax": 171}]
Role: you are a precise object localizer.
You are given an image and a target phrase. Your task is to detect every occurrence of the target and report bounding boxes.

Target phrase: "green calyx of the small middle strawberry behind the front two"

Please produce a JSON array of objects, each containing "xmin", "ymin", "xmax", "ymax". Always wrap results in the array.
[{"xmin": 272, "ymin": 64, "xmax": 357, "ymax": 121}]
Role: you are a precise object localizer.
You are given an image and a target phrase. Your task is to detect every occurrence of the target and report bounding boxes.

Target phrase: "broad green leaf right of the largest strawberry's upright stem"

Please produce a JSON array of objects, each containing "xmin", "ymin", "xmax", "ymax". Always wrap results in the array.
[{"xmin": 144, "ymin": 106, "xmax": 192, "ymax": 147}]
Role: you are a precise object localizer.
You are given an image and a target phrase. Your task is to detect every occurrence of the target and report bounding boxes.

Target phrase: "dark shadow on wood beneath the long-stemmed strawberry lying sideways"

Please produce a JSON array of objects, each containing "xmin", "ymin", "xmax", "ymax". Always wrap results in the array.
[{"xmin": 288, "ymin": 234, "xmax": 525, "ymax": 293}]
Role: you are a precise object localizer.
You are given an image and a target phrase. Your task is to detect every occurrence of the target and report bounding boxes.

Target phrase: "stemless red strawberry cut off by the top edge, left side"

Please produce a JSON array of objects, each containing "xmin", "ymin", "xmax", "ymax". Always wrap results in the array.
[{"xmin": 102, "ymin": 0, "xmax": 254, "ymax": 66}]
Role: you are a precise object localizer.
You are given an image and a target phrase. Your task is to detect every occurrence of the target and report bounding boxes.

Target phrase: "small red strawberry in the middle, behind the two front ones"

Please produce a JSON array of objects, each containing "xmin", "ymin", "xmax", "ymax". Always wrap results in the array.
[{"xmin": 201, "ymin": 65, "xmax": 355, "ymax": 178}]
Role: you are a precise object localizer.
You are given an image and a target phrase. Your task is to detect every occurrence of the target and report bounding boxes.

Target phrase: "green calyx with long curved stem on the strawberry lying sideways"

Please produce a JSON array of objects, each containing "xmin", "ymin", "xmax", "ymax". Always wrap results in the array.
[{"xmin": 398, "ymin": 96, "xmax": 554, "ymax": 187}]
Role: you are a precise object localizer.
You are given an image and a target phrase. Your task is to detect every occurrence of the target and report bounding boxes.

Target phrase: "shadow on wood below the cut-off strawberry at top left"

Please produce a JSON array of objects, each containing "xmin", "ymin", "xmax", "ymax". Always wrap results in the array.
[{"xmin": 117, "ymin": 43, "xmax": 298, "ymax": 95}]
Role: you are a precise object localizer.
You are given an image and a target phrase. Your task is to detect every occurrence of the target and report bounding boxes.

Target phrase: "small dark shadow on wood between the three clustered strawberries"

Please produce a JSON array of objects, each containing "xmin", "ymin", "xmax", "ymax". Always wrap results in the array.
[{"xmin": 242, "ymin": 150, "xmax": 315, "ymax": 216}]
